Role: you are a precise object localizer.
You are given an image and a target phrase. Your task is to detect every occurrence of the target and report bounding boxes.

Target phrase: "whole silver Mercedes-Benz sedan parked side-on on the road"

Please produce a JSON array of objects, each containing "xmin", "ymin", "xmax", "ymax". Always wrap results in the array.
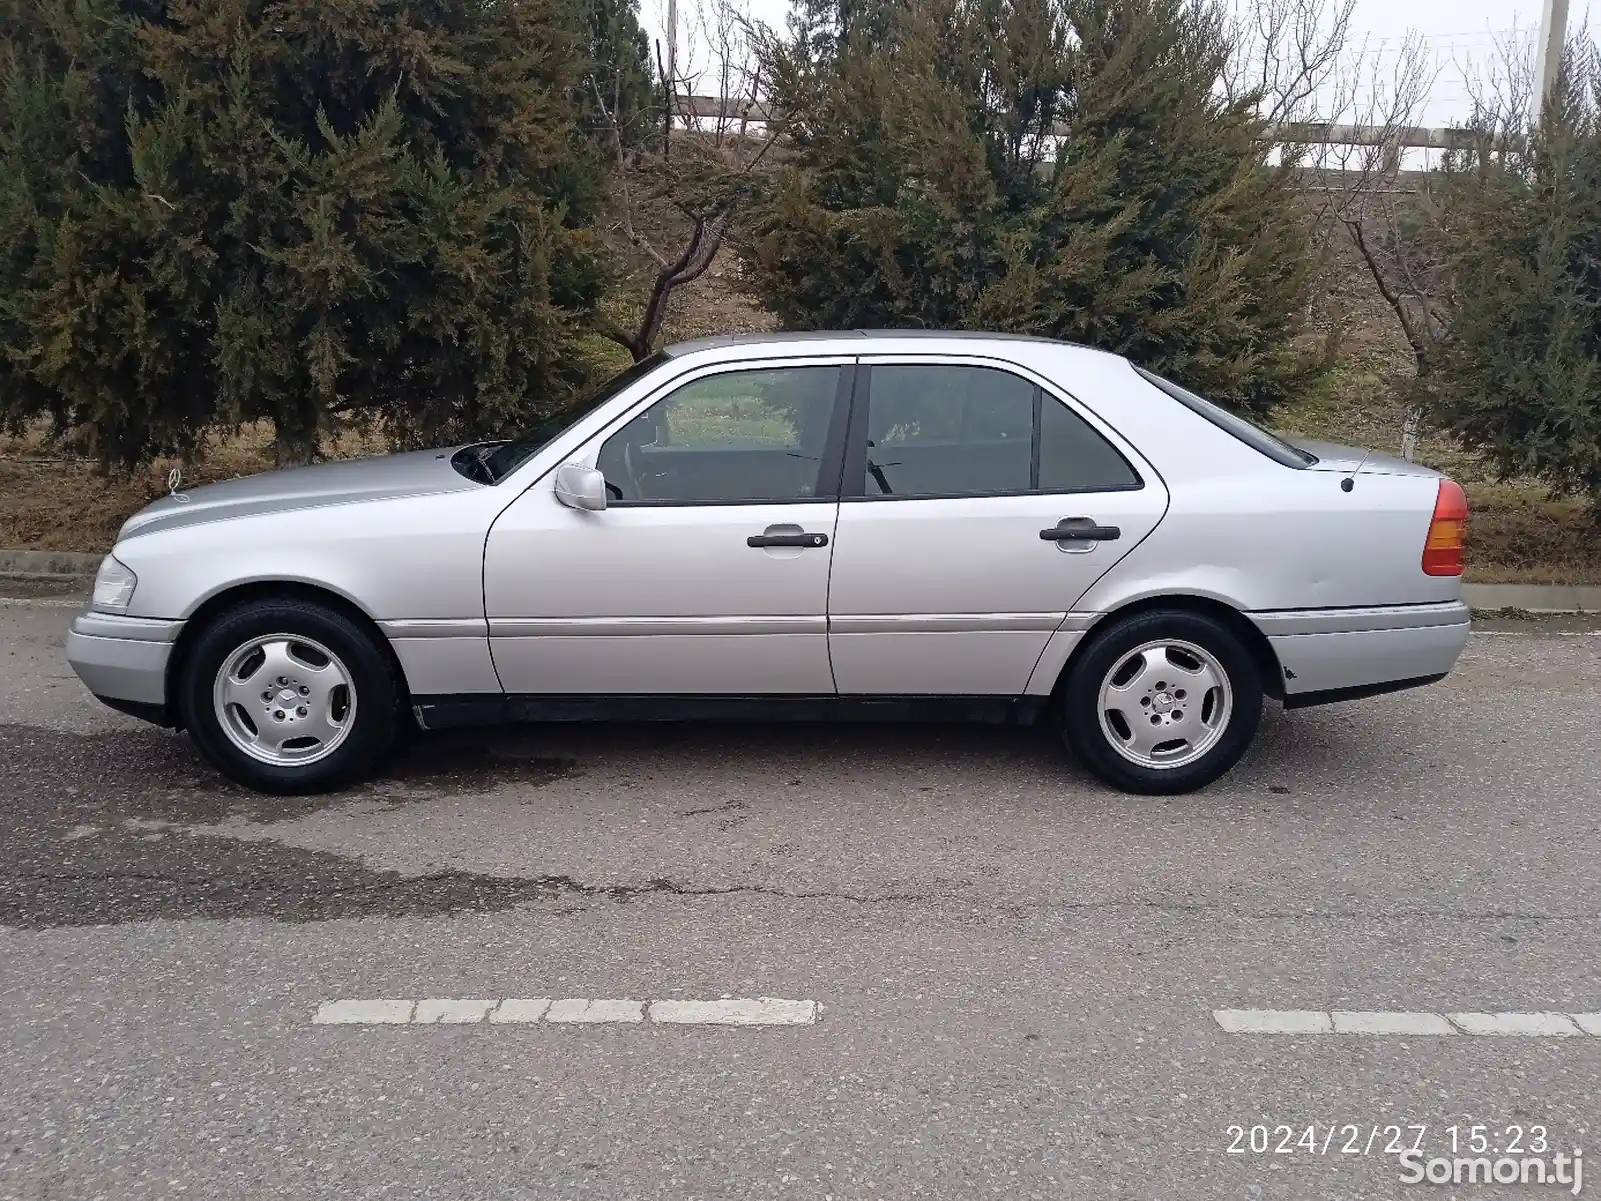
[{"xmin": 67, "ymin": 331, "xmax": 1468, "ymax": 793}]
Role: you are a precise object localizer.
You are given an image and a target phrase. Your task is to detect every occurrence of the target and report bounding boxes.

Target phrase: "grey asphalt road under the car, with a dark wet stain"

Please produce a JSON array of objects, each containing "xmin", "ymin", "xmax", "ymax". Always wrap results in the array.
[{"xmin": 0, "ymin": 589, "xmax": 1601, "ymax": 1201}]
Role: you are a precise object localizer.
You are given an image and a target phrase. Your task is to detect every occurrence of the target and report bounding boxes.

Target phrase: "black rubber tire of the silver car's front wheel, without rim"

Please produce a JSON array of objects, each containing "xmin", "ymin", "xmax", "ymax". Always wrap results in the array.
[{"xmin": 178, "ymin": 597, "xmax": 405, "ymax": 796}]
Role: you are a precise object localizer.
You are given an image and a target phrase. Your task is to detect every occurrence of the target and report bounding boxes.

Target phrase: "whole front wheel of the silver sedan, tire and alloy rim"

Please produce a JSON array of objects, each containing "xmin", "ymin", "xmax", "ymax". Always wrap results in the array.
[{"xmin": 179, "ymin": 599, "xmax": 402, "ymax": 794}]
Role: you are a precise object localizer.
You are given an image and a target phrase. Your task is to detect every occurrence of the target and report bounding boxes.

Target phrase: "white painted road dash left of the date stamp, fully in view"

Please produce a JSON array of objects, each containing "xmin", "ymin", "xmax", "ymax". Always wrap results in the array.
[{"xmin": 311, "ymin": 996, "xmax": 818, "ymax": 1026}]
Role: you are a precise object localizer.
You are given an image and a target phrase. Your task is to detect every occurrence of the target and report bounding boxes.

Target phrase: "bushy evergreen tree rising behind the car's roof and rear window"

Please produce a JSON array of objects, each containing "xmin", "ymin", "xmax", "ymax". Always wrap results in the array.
[{"xmin": 752, "ymin": 0, "xmax": 1324, "ymax": 413}]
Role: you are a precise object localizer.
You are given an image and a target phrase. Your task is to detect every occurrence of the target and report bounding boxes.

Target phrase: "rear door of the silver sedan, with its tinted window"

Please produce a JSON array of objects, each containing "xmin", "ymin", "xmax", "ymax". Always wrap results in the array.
[{"xmin": 828, "ymin": 355, "xmax": 1167, "ymax": 697}]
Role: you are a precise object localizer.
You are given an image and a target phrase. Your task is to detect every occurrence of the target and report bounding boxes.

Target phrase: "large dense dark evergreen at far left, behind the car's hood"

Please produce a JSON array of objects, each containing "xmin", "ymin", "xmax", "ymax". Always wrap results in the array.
[{"xmin": 0, "ymin": 0, "xmax": 602, "ymax": 464}]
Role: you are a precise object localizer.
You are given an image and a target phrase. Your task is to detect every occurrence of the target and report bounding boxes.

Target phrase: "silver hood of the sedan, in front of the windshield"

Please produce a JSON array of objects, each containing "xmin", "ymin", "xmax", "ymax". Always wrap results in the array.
[{"xmin": 117, "ymin": 447, "xmax": 484, "ymax": 541}]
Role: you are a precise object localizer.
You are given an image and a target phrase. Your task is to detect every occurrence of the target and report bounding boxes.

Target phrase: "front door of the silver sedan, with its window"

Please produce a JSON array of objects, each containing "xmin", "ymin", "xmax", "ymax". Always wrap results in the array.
[{"xmin": 484, "ymin": 359, "xmax": 852, "ymax": 697}]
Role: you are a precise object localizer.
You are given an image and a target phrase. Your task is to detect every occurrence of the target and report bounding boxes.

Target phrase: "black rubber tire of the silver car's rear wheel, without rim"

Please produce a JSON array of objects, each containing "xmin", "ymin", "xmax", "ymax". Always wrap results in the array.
[{"xmin": 1058, "ymin": 609, "xmax": 1262, "ymax": 796}]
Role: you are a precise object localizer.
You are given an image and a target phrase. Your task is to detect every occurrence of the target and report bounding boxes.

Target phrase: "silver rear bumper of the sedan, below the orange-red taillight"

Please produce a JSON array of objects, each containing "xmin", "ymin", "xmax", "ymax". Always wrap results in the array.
[{"xmin": 1250, "ymin": 601, "xmax": 1471, "ymax": 709}]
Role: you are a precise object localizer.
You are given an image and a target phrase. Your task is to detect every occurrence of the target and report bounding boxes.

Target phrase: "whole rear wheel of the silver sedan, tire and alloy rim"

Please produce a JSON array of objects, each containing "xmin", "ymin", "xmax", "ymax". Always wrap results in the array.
[{"xmin": 1061, "ymin": 610, "xmax": 1262, "ymax": 794}]
